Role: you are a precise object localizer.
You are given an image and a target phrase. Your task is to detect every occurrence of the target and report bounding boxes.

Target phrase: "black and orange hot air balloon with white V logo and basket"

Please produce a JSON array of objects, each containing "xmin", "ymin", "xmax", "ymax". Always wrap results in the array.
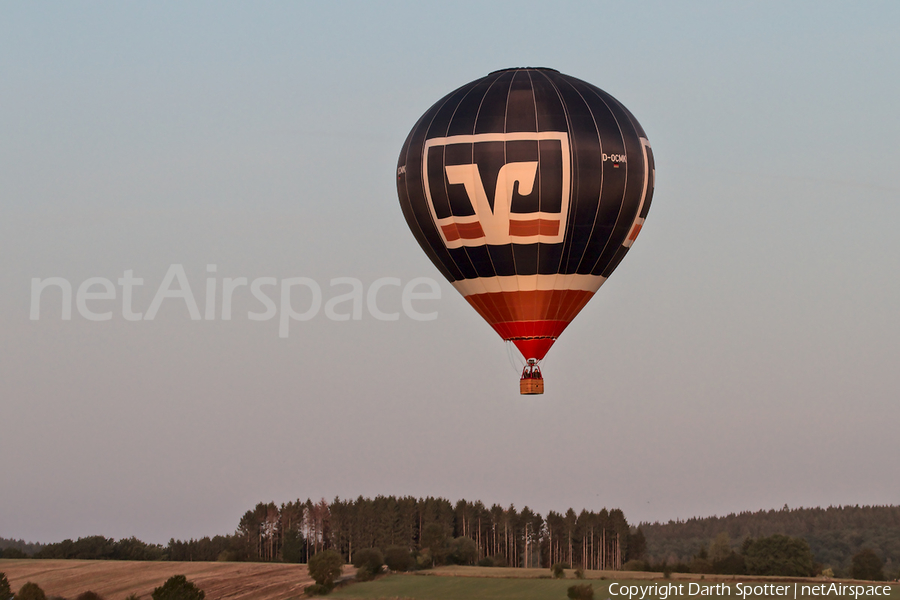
[{"xmin": 397, "ymin": 67, "xmax": 654, "ymax": 394}]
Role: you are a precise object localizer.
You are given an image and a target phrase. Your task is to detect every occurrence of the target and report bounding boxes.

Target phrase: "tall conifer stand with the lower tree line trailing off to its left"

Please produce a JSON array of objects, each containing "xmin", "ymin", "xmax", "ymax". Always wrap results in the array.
[{"xmin": 1, "ymin": 496, "xmax": 645, "ymax": 569}]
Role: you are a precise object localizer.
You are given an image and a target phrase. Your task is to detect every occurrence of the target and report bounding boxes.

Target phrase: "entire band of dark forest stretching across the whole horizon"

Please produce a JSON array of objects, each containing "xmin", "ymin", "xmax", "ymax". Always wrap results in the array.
[{"xmin": 0, "ymin": 496, "xmax": 900, "ymax": 577}]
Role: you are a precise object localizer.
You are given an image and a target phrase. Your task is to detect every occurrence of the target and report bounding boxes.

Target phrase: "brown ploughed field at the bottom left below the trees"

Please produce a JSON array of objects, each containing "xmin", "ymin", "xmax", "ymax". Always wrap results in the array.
[{"xmin": 0, "ymin": 559, "xmax": 330, "ymax": 600}]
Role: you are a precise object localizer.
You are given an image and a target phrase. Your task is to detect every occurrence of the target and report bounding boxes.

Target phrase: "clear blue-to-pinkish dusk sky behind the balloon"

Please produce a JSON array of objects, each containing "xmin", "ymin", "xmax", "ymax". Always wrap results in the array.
[{"xmin": 0, "ymin": 1, "xmax": 900, "ymax": 544}]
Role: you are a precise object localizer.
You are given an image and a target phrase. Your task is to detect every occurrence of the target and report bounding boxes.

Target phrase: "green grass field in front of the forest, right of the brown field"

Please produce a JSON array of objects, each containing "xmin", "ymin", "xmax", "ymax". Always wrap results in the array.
[{"xmin": 329, "ymin": 575, "xmax": 900, "ymax": 600}]
